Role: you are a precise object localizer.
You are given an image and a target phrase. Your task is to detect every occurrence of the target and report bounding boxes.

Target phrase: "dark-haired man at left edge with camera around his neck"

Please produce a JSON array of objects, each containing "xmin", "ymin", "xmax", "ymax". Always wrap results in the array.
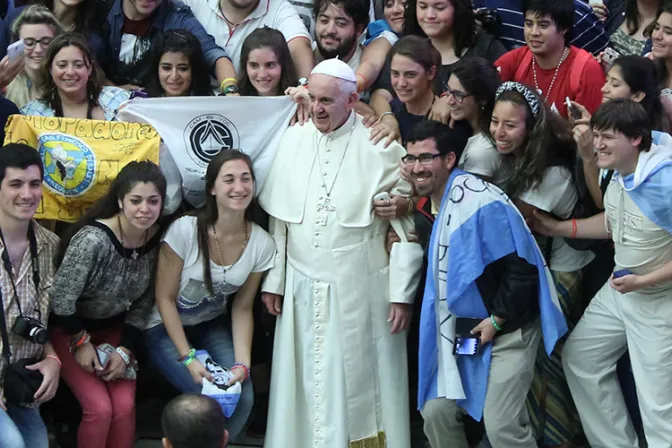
[{"xmin": 0, "ymin": 143, "xmax": 61, "ymax": 448}]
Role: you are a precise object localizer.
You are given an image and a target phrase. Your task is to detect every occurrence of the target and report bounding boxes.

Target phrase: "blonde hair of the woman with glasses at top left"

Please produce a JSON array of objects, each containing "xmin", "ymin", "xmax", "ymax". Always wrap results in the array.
[{"xmin": 5, "ymin": 5, "xmax": 63, "ymax": 109}]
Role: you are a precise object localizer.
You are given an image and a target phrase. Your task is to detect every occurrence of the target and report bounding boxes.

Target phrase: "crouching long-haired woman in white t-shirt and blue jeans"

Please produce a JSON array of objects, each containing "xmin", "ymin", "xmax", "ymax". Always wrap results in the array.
[{"xmin": 145, "ymin": 149, "xmax": 275, "ymax": 439}]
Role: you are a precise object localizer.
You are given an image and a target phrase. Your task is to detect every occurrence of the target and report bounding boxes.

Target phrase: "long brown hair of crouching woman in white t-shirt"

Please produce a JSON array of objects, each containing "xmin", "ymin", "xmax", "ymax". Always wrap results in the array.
[{"xmin": 196, "ymin": 149, "xmax": 256, "ymax": 297}]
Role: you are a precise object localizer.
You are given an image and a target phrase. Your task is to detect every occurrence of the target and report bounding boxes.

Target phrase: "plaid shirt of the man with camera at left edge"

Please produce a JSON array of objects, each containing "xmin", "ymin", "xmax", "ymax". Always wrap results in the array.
[{"xmin": 0, "ymin": 221, "xmax": 58, "ymax": 390}]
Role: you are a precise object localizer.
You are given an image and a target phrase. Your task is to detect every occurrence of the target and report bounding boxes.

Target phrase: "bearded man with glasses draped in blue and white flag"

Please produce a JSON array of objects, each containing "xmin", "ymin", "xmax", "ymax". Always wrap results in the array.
[{"xmin": 401, "ymin": 121, "xmax": 567, "ymax": 448}]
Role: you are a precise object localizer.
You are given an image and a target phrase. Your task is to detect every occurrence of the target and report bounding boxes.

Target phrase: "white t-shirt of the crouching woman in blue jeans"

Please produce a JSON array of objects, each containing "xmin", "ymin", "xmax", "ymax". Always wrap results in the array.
[{"xmin": 146, "ymin": 216, "xmax": 275, "ymax": 328}]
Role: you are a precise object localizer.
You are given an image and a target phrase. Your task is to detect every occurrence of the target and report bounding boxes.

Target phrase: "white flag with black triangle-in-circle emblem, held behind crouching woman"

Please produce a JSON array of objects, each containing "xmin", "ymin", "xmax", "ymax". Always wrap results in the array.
[{"xmin": 117, "ymin": 96, "xmax": 296, "ymax": 207}]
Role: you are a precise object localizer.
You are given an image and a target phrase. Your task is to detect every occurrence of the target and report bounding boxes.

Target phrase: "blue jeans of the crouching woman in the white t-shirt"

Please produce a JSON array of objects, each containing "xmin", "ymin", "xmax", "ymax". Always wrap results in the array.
[{"xmin": 145, "ymin": 317, "xmax": 254, "ymax": 440}]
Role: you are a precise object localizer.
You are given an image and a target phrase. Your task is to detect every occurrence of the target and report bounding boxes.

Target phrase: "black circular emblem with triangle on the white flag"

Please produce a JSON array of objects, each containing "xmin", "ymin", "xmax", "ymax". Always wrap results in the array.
[{"xmin": 184, "ymin": 114, "xmax": 240, "ymax": 167}]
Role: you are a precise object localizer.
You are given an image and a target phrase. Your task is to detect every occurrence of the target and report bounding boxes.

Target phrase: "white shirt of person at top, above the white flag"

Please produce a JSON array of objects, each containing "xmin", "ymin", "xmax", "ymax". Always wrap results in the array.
[{"xmin": 182, "ymin": 0, "xmax": 311, "ymax": 76}]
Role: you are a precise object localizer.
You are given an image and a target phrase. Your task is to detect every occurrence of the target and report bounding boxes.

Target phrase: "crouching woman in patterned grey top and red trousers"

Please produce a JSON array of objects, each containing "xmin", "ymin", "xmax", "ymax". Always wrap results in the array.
[{"xmin": 49, "ymin": 162, "xmax": 166, "ymax": 448}]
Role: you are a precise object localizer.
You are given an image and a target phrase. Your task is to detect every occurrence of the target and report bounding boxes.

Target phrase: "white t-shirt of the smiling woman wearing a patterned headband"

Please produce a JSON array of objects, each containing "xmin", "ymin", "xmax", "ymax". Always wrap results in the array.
[{"xmin": 519, "ymin": 166, "xmax": 595, "ymax": 272}]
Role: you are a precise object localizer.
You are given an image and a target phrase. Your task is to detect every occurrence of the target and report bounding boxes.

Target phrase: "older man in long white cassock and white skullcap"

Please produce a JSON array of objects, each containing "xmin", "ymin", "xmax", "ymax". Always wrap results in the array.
[{"xmin": 259, "ymin": 59, "xmax": 422, "ymax": 448}]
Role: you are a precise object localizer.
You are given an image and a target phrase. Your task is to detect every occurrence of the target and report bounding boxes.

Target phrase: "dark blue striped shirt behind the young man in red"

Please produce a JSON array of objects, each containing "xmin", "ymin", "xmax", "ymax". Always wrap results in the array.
[{"xmin": 474, "ymin": 0, "xmax": 609, "ymax": 54}]
